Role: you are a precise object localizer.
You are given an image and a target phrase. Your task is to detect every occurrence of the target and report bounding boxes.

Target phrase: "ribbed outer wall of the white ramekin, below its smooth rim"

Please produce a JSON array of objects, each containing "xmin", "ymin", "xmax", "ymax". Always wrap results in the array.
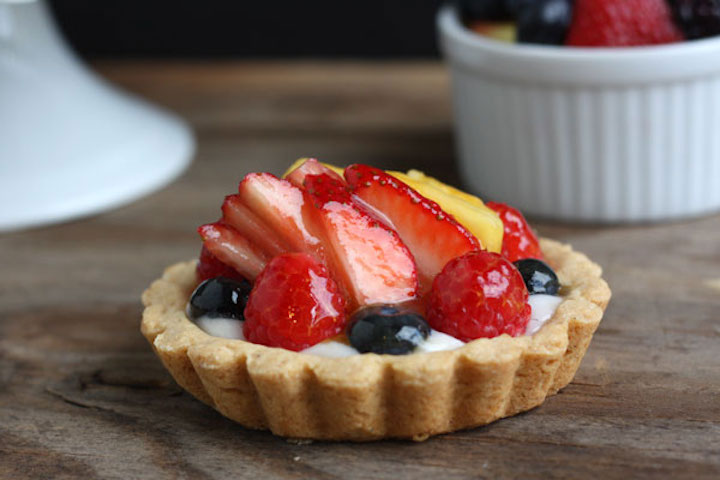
[{"xmin": 452, "ymin": 72, "xmax": 720, "ymax": 221}]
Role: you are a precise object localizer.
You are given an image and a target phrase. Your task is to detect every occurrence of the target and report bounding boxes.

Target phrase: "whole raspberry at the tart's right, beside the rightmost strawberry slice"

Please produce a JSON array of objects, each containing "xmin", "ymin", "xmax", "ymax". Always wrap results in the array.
[{"xmin": 427, "ymin": 251, "xmax": 531, "ymax": 342}]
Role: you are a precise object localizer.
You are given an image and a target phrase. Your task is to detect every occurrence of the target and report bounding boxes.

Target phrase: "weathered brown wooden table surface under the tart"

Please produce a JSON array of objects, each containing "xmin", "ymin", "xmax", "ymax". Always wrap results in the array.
[{"xmin": 0, "ymin": 63, "xmax": 720, "ymax": 479}]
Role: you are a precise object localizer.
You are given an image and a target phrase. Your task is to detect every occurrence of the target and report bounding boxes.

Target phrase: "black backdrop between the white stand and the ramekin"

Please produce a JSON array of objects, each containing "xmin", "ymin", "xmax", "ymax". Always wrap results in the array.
[{"xmin": 50, "ymin": 0, "xmax": 442, "ymax": 58}]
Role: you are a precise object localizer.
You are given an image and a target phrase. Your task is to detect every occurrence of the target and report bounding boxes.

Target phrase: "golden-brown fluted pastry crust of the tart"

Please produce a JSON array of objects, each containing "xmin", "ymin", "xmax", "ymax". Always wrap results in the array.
[{"xmin": 141, "ymin": 239, "xmax": 610, "ymax": 441}]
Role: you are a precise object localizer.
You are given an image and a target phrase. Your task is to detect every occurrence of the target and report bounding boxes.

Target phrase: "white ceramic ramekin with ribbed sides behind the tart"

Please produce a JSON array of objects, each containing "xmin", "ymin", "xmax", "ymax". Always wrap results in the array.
[{"xmin": 437, "ymin": 7, "xmax": 720, "ymax": 222}]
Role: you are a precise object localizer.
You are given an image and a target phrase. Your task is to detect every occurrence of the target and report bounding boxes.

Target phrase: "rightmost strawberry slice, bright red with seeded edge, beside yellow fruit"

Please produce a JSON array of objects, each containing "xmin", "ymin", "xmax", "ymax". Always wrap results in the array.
[{"xmin": 345, "ymin": 165, "xmax": 481, "ymax": 292}]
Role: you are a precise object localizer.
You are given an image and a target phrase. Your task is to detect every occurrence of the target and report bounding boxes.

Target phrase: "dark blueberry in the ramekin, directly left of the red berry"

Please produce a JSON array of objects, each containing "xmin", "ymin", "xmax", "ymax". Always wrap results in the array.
[{"xmin": 512, "ymin": 0, "xmax": 573, "ymax": 45}]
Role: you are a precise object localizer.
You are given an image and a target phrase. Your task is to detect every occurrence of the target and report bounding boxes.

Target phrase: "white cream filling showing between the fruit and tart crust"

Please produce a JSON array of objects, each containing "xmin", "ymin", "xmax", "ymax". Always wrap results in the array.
[{"xmin": 195, "ymin": 294, "xmax": 563, "ymax": 358}]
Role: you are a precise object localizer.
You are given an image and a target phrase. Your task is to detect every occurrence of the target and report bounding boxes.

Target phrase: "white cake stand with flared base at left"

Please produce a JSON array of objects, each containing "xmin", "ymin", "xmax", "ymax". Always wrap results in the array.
[{"xmin": 0, "ymin": 0, "xmax": 195, "ymax": 231}]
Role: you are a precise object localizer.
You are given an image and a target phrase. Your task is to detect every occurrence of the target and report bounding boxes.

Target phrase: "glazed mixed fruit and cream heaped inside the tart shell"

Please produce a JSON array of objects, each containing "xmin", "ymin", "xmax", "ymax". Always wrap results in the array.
[{"xmin": 188, "ymin": 160, "xmax": 559, "ymax": 356}]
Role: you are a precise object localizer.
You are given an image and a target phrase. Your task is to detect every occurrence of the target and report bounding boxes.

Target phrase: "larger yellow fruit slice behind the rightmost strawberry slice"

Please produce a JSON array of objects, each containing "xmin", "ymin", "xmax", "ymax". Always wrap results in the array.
[{"xmin": 387, "ymin": 170, "xmax": 503, "ymax": 253}]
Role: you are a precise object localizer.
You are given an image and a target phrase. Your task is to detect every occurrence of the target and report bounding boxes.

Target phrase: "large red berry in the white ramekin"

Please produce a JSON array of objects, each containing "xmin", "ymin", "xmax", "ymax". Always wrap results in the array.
[{"xmin": 566, "ymin": 0, "xmax": 683, "ymax": 47}]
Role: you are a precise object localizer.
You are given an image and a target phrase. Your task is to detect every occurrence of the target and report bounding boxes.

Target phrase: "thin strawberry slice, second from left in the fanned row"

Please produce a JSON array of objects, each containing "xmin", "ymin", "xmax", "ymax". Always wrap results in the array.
[{"xmin": 222, "ymin": 195, "xmax": 289, "ymax": 257}]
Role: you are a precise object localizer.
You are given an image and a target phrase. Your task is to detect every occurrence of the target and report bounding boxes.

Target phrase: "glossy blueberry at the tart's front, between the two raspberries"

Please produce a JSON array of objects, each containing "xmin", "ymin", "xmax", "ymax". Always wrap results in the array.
[{"xmin": 348, "ymin": 305, "xmax": 430, "ymax": 355}]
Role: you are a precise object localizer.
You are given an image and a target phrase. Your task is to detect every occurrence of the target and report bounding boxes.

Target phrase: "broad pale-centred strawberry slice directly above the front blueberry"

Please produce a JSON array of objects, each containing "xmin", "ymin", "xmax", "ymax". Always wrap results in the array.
[{"xmin": 305, "ymin": 174, "xmax": 418, "ymax": 307}]
